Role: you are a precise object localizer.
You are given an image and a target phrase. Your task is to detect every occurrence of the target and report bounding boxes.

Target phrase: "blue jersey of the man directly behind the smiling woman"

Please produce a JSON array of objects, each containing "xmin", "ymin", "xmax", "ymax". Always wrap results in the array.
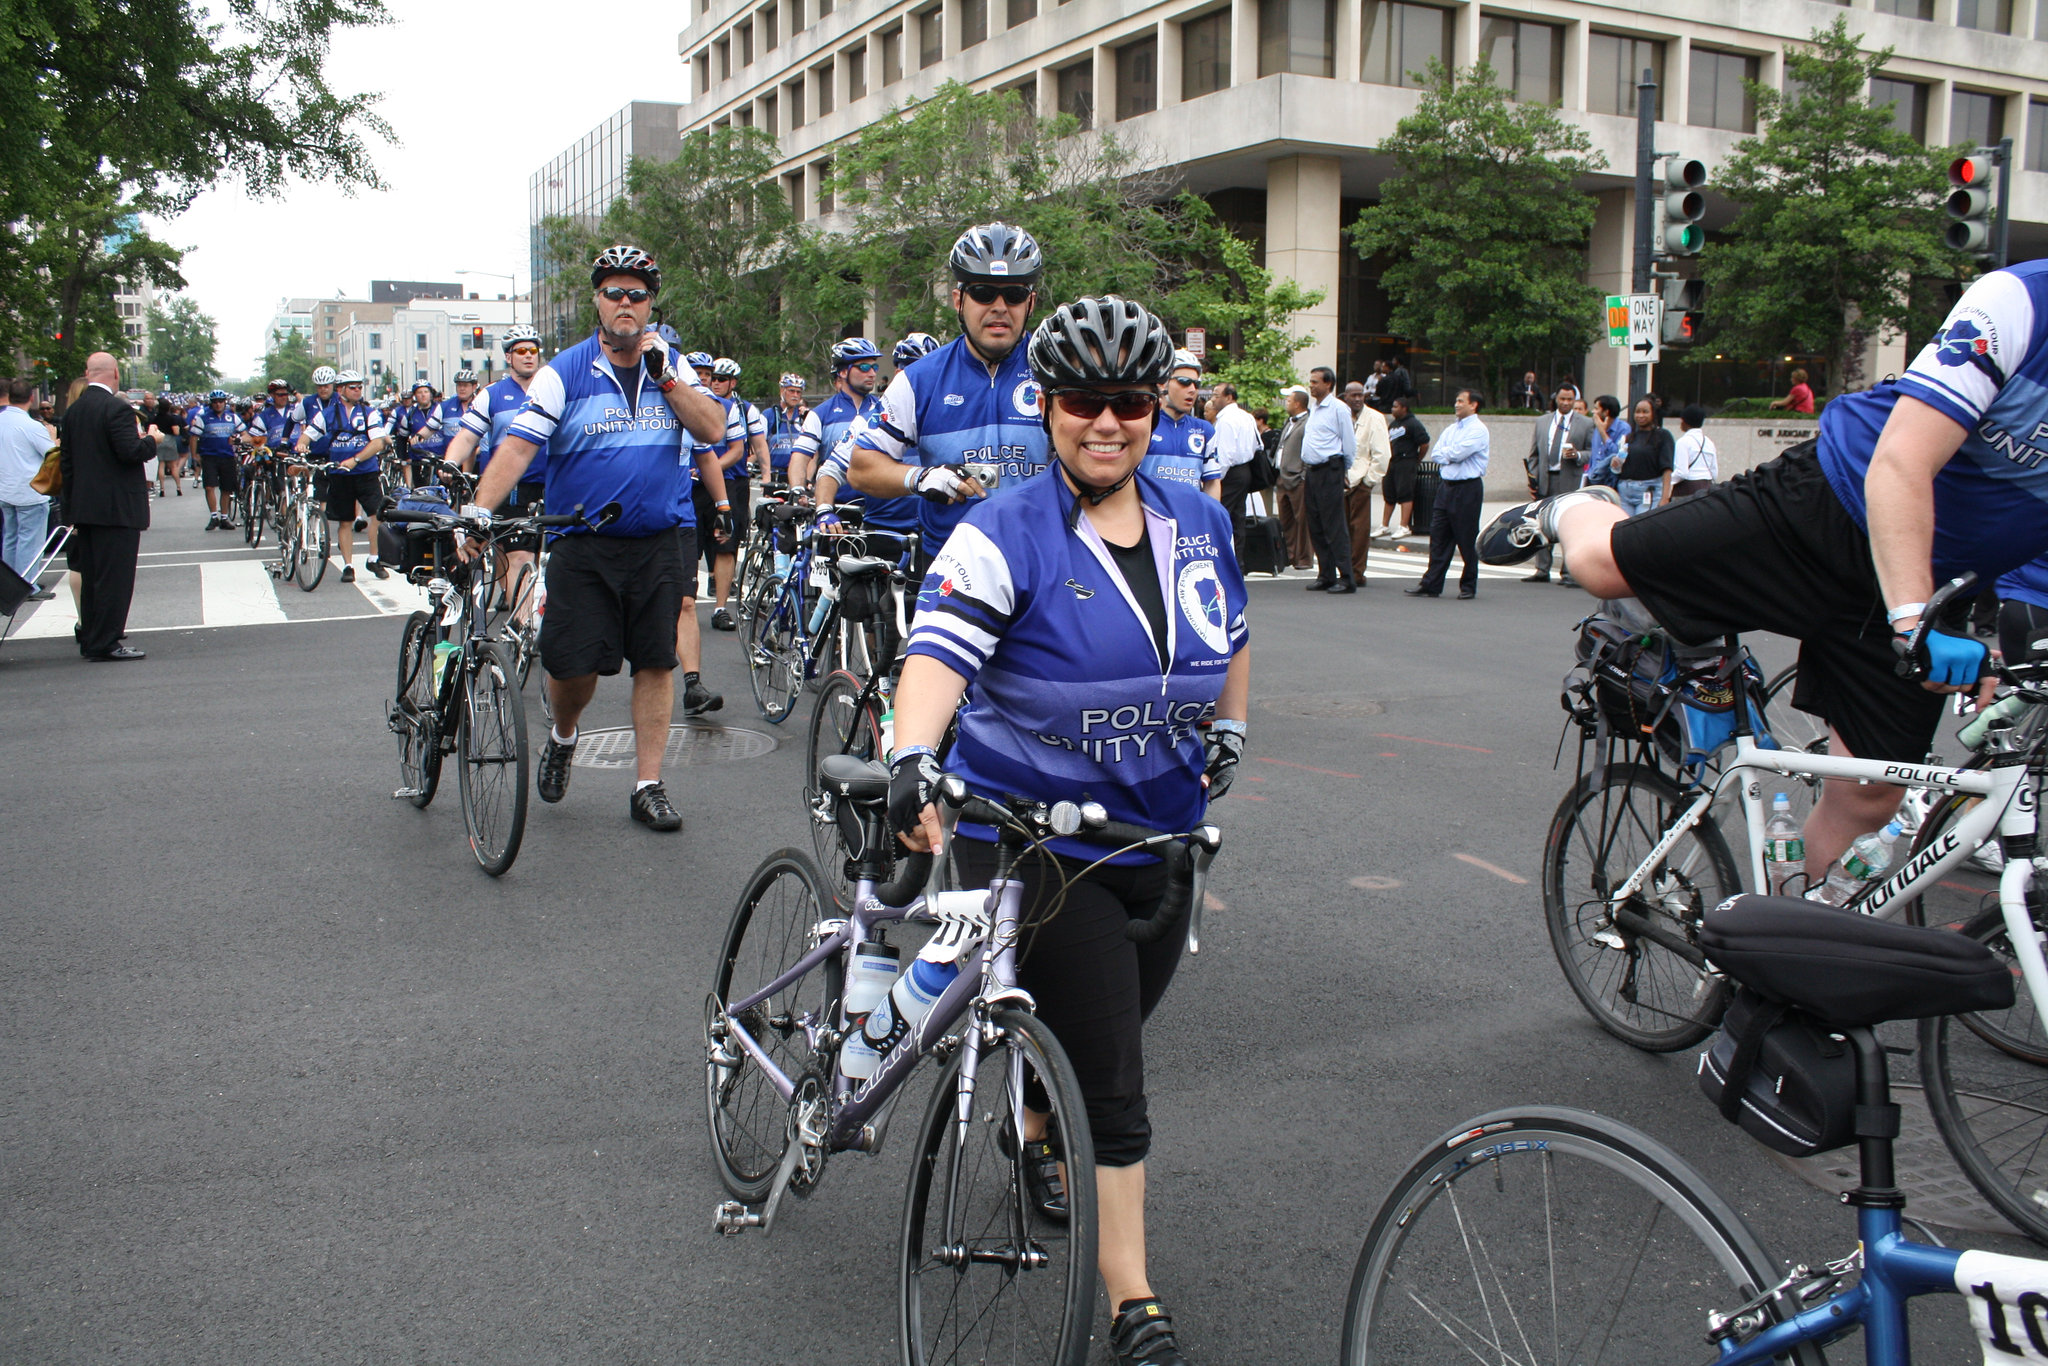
[{"xmin": 854, "ymin": 336, "xmax": 1053, "ymax": 545}]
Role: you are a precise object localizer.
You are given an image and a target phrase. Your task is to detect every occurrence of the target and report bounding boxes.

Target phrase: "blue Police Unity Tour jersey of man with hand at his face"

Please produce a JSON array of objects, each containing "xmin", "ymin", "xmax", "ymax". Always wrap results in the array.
[{"xmin": 510, "ymin": 334, "xmax": 711, "ymax": 537}]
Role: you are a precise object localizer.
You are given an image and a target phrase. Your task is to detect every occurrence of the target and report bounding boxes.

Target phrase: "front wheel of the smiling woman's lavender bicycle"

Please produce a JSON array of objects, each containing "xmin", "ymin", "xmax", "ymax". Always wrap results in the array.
[{"xmin": 897, "ymin": 1010, "xmax": 1098, "ymax": 1366}]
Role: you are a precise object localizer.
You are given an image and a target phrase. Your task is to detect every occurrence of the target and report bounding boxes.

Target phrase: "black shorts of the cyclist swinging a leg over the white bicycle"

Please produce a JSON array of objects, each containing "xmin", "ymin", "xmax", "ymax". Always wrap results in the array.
[{"xmin": 1612, "ymin": 440, "xmax": 1933, "ymax": 764}]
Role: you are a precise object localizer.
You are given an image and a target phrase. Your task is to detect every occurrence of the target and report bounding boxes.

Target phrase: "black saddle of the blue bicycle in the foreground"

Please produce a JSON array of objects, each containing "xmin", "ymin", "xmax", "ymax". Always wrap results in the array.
[{"xmin": 1700, "ymin": 895, "xmax": 2013, "ymax": 1028}]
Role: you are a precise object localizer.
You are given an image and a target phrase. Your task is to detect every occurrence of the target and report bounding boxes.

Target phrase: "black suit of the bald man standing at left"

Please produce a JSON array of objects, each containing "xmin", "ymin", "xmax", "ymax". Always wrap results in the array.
[{"xmin": 61, "ymin": 385, "xmax": 156, "ymax": 659}]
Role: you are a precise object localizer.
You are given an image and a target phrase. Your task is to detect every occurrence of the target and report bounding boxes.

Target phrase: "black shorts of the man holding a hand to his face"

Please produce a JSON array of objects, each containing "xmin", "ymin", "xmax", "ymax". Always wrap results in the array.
[{"xmin": 541, "ymin": 528, "xmax": 696, "ymax": 678}]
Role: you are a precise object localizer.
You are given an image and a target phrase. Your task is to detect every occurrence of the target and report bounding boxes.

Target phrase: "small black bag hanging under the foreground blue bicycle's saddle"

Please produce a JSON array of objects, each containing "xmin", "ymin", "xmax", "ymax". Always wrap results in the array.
[{"xmin": 1700, "ymin": 987, "xmax": 1855, "ymax": 1157}]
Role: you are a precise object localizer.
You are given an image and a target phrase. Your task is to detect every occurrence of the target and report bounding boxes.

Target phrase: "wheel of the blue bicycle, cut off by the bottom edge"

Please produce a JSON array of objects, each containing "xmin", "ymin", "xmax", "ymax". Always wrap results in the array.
[{"xmin": 1337, "ymin": 1106, "xmax": 1823, "ymax": 1366}]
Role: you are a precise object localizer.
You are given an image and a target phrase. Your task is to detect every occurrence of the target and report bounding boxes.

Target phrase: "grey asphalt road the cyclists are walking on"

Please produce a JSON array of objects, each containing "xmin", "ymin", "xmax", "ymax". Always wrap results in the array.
[{"xmin": 0, "ymin": 496, "xmax": 2011, "ymax": 1366}]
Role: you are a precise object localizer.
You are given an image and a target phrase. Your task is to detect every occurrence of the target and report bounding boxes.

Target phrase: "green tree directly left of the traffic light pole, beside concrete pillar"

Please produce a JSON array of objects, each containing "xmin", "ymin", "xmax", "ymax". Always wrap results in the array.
[{"xmin": 1350, "ymin": 59, "xmax": 1606, "ymax": 393}]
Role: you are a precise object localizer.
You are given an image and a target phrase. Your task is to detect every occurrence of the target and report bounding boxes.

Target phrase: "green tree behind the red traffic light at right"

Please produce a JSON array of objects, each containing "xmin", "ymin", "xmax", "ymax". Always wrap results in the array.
[{"xmin": 1700, "ymin": 18, "xmax": 1968, "ymax": 389}]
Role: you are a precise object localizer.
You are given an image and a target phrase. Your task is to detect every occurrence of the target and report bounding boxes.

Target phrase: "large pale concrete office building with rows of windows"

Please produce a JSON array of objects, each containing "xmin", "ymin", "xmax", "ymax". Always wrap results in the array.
[{"xmin": 678, "ymin": 0, "xmax": 2048, "ymax": 391}]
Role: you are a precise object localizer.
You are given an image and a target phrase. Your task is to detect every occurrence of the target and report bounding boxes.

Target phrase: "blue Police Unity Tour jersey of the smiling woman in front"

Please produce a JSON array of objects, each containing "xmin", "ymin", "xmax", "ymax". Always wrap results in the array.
[{"xmin": 907, "ymin": 475, "xmax": 1249, "ymax": 858}]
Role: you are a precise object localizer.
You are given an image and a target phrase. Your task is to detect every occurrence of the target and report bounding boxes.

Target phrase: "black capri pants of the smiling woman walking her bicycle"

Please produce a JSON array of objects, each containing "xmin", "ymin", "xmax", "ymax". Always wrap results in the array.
[{"xmin": 952, "ymin": 840, "xmax": 1186, "ymax": 1167}]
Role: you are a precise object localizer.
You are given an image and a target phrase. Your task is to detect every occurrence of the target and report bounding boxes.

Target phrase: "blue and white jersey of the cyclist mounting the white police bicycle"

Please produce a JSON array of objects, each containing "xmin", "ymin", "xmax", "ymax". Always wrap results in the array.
[{"xmin": 1821, "ymin": 260, "xmax": 2048, "ymax": 584}]
